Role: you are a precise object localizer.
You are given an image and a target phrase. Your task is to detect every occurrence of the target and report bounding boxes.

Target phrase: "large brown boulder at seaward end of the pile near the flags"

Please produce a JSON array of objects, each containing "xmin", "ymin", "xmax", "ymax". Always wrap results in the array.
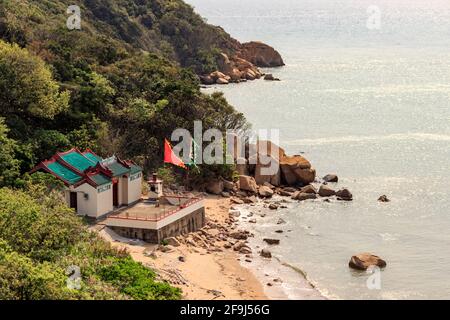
[{"xmin": 280, "ymin": 155, "xmax": 316, "ymax": 185}]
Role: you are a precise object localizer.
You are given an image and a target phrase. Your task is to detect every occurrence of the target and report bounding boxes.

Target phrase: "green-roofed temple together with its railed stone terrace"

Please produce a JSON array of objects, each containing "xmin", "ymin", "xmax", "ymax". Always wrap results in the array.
[{"xmin": 31, "ymin": 149, "xmax": 205, "ymax": 243}]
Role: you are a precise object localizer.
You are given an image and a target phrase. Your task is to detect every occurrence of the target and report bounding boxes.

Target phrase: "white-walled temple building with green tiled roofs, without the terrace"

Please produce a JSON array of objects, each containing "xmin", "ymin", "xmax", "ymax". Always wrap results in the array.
[{"xmin": 31, "ymin": 149, "xmax": 143, "ymax": 218}]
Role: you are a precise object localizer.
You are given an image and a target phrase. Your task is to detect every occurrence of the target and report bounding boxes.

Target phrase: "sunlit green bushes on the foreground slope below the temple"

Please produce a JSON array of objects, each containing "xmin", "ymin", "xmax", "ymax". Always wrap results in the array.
[{"xmin": 0, "ymin": 183, "xmax": 181, "ymax": 299}]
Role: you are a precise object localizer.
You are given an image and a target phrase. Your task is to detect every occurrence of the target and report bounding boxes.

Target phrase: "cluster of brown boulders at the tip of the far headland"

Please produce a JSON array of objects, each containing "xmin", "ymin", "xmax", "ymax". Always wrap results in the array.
[{"xmin": 199, "ymin": 42, "xmax": 284, "ymax": 85}]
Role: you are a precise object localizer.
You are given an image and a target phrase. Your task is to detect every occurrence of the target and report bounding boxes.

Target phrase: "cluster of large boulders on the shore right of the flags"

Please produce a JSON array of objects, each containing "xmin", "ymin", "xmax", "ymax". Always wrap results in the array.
[{"xmin": 205, "ymin": 141, "xmax": 353, "ymax": 204}]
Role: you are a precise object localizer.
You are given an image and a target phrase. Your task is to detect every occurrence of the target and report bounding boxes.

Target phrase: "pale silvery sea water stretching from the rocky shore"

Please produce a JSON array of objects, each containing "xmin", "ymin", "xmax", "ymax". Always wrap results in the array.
[{"xmin": 188, "ymin": 0, "xmax": 450, "ymax": 299}]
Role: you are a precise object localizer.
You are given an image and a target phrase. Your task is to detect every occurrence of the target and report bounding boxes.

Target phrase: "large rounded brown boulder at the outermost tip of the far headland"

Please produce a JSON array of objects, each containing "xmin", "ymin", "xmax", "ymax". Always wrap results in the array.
[{"xmin": 238, "ymin": 41, "xmax": 284, "ymax": 68}]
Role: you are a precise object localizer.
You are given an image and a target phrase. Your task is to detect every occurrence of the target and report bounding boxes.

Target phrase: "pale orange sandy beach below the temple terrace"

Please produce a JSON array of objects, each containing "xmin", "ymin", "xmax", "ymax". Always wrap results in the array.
[{"xmin": 100, "ymin": 196, "xmax": 267, "ymax": 300}]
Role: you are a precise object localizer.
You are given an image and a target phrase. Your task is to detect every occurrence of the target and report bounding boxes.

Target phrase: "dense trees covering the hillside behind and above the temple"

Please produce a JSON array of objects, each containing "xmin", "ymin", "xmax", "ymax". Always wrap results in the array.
[{"xmin": 0, "ymin": 0, "xmax": 247, "ymax": 180}]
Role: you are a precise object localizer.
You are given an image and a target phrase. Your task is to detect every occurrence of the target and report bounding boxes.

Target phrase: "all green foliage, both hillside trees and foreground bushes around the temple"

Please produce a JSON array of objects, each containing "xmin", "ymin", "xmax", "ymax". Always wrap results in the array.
[{"xmin": 0, "ymin": 0, "xmax": 247, "ymax": 299}]
